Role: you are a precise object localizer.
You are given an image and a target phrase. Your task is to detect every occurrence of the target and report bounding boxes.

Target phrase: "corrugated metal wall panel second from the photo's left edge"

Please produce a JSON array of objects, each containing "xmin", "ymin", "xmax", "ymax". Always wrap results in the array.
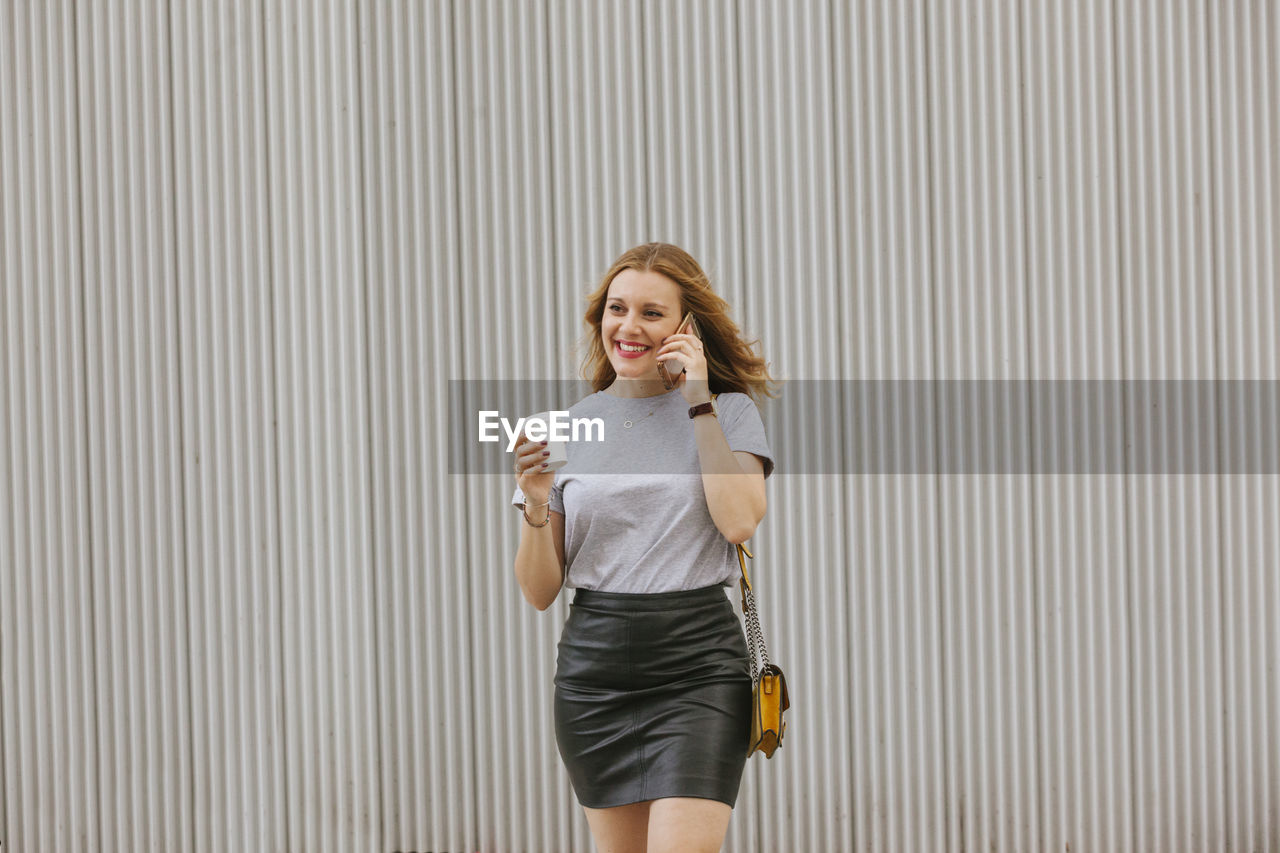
[{"xmin": 75, "ymin": 3, "xmax": 192, "ymax": 850}]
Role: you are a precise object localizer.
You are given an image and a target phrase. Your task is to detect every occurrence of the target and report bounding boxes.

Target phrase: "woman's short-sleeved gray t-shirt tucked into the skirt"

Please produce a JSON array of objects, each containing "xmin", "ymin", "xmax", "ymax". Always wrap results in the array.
[{"xmin": 512, "ymin": 389, "xmax": 773, "ymax": 593}]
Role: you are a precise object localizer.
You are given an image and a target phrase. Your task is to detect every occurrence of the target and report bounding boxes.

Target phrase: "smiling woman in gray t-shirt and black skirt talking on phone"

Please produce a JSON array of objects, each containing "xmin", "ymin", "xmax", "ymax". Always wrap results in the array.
[{"xmin": 513, "ymin": 243, "xmax": 773, "ymax": 853}]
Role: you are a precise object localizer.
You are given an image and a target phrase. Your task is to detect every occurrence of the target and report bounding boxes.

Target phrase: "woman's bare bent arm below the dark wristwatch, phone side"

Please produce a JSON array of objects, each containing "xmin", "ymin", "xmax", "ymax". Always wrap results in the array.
[{"xmin": 694, "ymin": 415, "xmax": 765, "ymax": 544}]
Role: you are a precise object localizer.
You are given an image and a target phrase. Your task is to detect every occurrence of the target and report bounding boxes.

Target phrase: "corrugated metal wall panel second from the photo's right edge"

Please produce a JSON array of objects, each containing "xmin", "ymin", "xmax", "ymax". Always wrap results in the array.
[{"xmin": 1116, "ymin": 3, "xmax": 1225, "ymax": 849}]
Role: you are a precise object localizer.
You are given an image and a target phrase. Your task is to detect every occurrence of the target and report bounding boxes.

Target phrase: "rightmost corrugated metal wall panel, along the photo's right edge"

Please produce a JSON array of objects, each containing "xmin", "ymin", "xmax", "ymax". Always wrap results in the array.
[{"xmin": 1206, "ymin": 4, "xmax": 1280, "ymax": 849}]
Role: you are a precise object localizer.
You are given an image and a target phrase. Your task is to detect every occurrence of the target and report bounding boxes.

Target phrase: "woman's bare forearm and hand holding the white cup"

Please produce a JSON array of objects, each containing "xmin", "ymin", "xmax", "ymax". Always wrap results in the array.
[{"xmin": 516, "ymin": 435, "xmax": 564, "ymax": 610}]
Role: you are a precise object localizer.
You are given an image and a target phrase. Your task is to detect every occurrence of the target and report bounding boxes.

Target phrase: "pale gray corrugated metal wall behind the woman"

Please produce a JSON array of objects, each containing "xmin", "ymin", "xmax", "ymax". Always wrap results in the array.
[{"xmin": 0, "ymin": 0, "xmax": 1280, "ymax": 853}]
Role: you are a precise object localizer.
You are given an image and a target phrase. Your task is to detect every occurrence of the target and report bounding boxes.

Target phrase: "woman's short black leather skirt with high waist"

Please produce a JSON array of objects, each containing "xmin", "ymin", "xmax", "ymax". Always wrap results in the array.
[{"xmin": 556, "ymin": 587, "xmax": 751, "ymax": 808}]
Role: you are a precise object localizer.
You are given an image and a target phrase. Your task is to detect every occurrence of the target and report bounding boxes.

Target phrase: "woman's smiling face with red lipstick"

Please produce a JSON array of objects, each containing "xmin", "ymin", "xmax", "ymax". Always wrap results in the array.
[{"xmin": 600, "ymin": 269, "xmax": 681, "ymax": 379}]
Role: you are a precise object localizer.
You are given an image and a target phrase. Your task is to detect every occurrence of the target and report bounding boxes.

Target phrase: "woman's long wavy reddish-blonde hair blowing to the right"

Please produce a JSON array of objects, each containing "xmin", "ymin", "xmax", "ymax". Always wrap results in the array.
[{"xmin": 580, "ymin": 243, "xmax": 780, "ymax": 401}]
